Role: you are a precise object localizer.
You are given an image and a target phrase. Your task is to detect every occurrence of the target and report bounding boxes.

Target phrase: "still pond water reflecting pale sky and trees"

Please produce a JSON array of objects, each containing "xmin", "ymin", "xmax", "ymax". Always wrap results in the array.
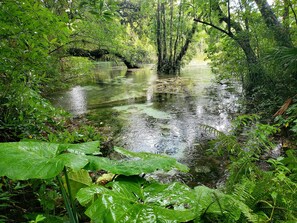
[{"xmin": 52, "ymin": 62, "xmax": 240, "ymax": 186}]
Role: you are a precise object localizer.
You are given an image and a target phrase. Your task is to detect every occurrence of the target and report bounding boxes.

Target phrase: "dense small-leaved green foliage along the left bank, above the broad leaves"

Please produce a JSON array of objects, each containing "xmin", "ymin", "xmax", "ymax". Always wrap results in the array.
[{"xmin": 0, "ymin": 0, "xmax": 69, "ymax": 141}]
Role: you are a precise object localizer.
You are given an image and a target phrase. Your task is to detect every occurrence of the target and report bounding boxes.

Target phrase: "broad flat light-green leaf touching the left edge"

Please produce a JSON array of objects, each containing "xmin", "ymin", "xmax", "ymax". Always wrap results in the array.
[{"xmin": 0, "ymin": 141, "xmax": 99, "ymax": 180}]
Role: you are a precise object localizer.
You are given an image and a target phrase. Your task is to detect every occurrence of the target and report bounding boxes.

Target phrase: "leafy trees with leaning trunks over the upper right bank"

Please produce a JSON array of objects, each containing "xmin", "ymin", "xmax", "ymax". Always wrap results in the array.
[{"xmin": 195, "ymin": 0, "xmax": 297, "ymax": 111}]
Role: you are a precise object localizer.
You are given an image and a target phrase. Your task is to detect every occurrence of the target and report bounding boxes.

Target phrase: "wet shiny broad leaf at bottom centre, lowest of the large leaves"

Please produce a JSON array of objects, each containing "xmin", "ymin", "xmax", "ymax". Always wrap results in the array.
[{"xmin": 77, "ymin": 177, "xmax": 196, "ymax": 223}]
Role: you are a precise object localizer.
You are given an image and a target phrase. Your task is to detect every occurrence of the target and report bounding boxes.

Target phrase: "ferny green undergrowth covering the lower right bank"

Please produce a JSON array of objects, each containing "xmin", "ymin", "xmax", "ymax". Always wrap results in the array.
[{"xmin": 202, "ymin": 100, "xmax": 297, "ymax": 222}]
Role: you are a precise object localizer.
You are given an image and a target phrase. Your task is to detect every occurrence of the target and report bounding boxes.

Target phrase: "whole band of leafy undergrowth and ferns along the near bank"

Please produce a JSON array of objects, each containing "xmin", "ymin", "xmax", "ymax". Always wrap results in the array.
[{"xmin": 0, "ymin": 104, "xmax": 297, "ymax": 223}]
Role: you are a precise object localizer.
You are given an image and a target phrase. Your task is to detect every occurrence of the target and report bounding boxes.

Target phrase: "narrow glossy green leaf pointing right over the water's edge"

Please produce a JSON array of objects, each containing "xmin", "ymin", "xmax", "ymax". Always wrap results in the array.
[{"xmin": 88, "ymin": 147, "xmax": 188, "ymax": 176}]
